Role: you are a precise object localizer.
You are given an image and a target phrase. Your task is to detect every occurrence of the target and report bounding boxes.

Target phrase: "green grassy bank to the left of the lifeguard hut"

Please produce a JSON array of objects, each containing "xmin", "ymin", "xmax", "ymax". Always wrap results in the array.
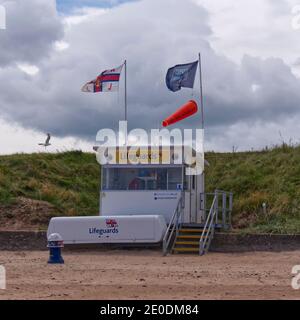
[{"xmin": 0, "ymin": 151, "xmax": 100, "ymax": 216}]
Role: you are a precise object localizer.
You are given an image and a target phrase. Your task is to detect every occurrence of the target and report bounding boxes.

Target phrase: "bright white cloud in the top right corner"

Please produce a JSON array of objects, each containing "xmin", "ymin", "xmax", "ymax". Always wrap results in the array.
[{"xmin": 193, "ymin": 0, "xmax": 300, "ymax": 75}]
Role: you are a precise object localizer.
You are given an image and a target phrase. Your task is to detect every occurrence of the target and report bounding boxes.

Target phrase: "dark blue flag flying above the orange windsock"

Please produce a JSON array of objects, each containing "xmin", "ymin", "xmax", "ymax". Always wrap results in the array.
[{"xmin": 166, "ymin": 61, "xmax": 198, "ymax": 92}]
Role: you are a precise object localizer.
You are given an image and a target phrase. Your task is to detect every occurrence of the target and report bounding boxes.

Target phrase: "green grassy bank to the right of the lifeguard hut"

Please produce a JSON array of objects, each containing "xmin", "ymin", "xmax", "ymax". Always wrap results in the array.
[{"xmin": 206, "ymin": 144, "xmax": 300, "ymax": 234}]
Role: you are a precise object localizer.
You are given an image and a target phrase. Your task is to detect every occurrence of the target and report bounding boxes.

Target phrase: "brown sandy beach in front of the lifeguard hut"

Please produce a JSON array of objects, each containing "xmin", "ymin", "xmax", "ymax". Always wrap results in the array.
[{"xmin": 0, "ymin": 250, "xmax": 300, "ymax": 299}]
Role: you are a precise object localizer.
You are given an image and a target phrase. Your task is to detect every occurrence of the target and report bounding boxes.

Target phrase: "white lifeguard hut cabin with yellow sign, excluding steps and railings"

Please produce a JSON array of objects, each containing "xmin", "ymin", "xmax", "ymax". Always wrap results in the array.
[{"xmin": 99, "ymin": 146, "xmax": 205, "ymax": 224}]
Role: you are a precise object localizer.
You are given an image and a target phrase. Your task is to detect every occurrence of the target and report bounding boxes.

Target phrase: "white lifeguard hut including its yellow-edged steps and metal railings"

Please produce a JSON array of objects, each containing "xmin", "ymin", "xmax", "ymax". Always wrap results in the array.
[{"xmin": 99, "ymin": 146, "xmax": 232, "ymax": 254}]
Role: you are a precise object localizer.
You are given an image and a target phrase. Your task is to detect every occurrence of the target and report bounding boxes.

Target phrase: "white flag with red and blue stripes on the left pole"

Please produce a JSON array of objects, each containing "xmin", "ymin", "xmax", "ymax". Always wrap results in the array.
[{"xmin": 81, "ymin": 64, "xmax": 124, "ymax": 92}]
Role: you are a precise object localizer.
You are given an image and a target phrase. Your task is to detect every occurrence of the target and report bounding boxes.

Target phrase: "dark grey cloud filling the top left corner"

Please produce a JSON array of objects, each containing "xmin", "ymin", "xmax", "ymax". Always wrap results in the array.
[{"xmin": 0, "ymin": 0, "xmax": 63, "ymax": 67}]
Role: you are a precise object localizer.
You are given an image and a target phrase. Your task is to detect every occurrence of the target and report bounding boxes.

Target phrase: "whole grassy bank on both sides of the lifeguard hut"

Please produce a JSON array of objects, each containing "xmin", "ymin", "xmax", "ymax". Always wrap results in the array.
[{"xmin": 0, "ymin": 144, "xmax": 300, "ymax": 234}]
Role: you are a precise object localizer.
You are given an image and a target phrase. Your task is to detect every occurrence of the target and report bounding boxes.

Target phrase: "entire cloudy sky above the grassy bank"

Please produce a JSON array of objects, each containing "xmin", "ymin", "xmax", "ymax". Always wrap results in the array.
[{"xmin": 0, "ymin": 0, "xmax": 300, "ymax": 154}]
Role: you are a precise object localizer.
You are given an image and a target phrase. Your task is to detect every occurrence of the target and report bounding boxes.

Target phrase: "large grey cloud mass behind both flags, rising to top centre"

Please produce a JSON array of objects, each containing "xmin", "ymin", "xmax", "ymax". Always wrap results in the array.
[{"xmin": 0, "ymin": 0, "xmax": 300, "ymax": 148}]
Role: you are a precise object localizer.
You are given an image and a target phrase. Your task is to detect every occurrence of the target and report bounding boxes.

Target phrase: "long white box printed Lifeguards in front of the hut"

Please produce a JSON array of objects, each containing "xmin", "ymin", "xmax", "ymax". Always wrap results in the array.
[{"xmin": 47, "ymin": 215, "xmax": 167, "ymax": 244}]
